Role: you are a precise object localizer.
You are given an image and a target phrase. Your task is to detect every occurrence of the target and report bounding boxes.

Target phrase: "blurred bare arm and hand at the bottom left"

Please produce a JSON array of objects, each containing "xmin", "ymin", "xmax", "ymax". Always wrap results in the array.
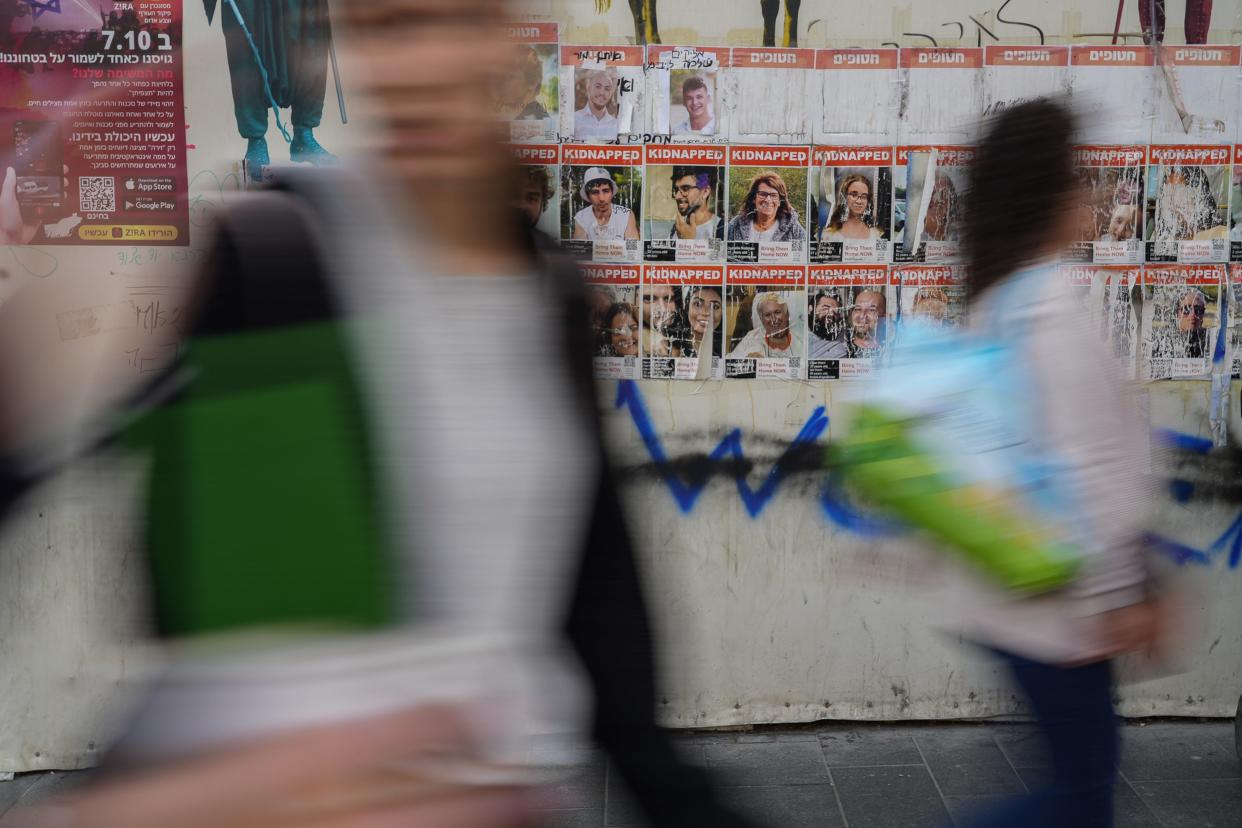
[{"xmin": 0, "ymin": 709, "xmax": 537, "ymax": 828}]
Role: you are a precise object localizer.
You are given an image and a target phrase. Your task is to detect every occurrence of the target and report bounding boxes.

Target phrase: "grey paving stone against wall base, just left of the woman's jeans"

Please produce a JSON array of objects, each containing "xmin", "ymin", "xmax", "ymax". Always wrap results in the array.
[{"xmin": 914, "ymin": 727, "xmax": 1026, "ymax": 797}]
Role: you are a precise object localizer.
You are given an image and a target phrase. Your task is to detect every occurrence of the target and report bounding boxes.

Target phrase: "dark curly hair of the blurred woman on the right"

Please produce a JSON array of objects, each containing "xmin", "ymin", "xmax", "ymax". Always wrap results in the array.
[{"xmin": 961, "ymin": 98, "xmax": 1076, "ymax": 300}]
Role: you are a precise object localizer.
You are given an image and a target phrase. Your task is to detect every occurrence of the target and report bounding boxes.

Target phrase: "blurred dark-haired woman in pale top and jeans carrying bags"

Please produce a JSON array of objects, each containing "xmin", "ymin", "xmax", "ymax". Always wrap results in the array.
[{"xmin": 953, "ymin": 99, "xmax": 1158, "ymax": 828}]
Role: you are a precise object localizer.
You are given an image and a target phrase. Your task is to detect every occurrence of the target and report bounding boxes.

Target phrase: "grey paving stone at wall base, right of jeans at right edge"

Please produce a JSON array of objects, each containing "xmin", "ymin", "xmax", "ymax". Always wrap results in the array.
[{"xmin": 1122, "ymin": 721, "xmax": 1242, "ymax": 787}]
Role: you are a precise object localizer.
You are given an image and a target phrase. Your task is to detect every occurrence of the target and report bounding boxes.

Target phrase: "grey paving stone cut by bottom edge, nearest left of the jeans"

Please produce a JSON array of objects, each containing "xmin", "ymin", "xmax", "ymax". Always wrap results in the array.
[{"xmin": 832, "ymin": 765, "xmax": 950, "ymax": 828}]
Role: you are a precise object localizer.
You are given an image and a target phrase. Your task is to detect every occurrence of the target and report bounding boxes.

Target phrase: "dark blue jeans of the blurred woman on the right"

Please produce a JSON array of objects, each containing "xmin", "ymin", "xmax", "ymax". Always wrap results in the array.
[{"xmin": 953, "ymin": 653, "xmax": 1120, "ymax": 828}]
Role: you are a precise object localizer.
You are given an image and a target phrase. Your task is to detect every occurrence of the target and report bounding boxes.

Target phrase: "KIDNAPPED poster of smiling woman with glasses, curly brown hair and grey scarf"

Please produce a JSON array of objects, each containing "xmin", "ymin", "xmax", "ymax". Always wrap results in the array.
[{"xmin": 725, "ymin": 144, "xmax": 811, "ymax": 264}]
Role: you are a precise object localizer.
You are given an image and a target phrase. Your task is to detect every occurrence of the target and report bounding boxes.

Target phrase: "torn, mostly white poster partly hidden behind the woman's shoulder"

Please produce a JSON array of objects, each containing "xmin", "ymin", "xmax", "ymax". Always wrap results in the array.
[{"xmin": 1061, "ymin": 264, "xmax": 1143, "ymax": 380}]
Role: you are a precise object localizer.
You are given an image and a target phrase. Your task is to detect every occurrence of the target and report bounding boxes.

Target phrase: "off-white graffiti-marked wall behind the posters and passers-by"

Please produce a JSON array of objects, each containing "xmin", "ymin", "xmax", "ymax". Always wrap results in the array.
[{"xmin": 0, "ymin": 0, "xmax": 1242, "ymax": 771}]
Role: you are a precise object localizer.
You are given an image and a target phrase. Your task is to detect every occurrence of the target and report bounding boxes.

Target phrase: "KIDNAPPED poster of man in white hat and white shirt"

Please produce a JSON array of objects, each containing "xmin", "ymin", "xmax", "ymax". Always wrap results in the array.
[{"xmin": 560, "ymin": 144, "xmax": 642, "ymax": 262}]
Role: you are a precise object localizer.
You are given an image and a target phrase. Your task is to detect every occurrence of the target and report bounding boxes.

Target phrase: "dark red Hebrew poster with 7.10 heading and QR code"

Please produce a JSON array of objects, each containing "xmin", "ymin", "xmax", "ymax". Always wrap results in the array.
[{"xmin": 0, "ymin": 0, "xmax": 190, "ymax": 245}]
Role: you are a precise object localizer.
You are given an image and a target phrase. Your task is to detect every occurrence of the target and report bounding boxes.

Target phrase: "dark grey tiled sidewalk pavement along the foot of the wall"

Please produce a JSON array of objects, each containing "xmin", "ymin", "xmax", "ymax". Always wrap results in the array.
[{"xmin": 0, "ymin": 720, "xmax": 1242, "ymax": 828}]
